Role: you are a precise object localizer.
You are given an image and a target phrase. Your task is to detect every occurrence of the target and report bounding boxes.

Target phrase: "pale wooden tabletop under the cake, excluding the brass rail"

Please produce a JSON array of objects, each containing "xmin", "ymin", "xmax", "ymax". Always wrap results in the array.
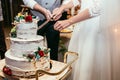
[{"xmin": 0, "ymin": 59, "xmax": 69, "ymax": 80}]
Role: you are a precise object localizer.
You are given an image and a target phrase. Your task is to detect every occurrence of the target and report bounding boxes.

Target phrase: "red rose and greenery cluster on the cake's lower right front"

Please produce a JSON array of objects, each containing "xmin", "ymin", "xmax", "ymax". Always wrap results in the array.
[{"xmin": 23, "ymin": 47, "xmax": 50, "ymax": 62}]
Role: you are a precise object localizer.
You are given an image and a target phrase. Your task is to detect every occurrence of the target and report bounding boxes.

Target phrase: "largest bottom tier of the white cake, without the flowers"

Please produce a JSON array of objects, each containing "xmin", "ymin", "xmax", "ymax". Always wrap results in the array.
[{"xmin": 5, "ymin": 50, "xmax": 50, "ymax": 76}]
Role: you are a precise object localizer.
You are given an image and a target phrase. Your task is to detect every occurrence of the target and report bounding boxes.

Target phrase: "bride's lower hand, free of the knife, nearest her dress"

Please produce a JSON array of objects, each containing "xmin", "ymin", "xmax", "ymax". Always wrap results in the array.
[{"xmin": 54, "ymin": 20, "xmax": 71, "ymax": 31}]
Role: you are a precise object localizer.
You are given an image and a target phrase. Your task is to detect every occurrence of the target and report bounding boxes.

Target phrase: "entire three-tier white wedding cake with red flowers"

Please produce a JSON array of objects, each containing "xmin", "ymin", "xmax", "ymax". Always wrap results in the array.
[{"xmin": 3, "ymin": 15, "xmax": 50, "ymax": 76}]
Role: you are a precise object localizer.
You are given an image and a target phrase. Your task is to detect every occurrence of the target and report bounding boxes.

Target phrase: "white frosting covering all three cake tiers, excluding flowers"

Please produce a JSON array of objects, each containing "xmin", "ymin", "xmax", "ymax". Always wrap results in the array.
[{"xmin": 5, "ymin": 19, "xmax": 50, "ymax": 76}]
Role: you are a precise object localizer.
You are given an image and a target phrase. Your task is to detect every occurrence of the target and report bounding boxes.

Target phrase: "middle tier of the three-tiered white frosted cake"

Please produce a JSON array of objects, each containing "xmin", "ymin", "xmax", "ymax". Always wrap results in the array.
[{"xmin": 10, "ymin": 36, "xmax": 44, "ymax": 57}]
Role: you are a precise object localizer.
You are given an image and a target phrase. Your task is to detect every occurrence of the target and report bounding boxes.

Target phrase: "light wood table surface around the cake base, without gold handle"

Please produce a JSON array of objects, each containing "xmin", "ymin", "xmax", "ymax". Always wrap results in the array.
[{"xmin": 0, "ymin": 59, "xmax": 71, "ymax": 80}]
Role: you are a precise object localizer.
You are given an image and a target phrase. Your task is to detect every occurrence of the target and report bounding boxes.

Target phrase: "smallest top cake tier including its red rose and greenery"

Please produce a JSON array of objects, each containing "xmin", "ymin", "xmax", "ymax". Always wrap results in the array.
[{"xmin": 11, "ymin": 13, "xmax": 39, "ymax": 39}]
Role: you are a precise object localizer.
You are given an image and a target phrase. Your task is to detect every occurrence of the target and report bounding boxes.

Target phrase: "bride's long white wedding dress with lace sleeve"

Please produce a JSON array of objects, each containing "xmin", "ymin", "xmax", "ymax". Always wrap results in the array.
[{"xmin": 68, "ymin": 0, "xmax": 120, "ymax": 80}]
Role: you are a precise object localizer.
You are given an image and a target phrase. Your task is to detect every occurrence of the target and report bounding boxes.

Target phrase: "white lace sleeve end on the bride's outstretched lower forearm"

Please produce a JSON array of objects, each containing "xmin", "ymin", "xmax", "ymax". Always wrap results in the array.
[{"xmin": 88, "ymin": 0, "xmax": 101, "ymax": 17}]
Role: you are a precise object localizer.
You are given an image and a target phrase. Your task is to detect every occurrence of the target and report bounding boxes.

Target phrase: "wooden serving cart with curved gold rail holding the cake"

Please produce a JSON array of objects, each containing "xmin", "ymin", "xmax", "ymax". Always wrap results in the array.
[{"xmin": 0, "ymin": 52, "xmax": 78, "ymax": 80}]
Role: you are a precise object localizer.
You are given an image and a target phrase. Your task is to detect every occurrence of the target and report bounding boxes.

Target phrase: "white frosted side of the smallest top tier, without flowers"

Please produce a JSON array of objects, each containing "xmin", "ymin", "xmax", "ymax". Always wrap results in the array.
[{"xmin": 16, "ymin": 22, "xmax": 37, "ymax": 39}]
